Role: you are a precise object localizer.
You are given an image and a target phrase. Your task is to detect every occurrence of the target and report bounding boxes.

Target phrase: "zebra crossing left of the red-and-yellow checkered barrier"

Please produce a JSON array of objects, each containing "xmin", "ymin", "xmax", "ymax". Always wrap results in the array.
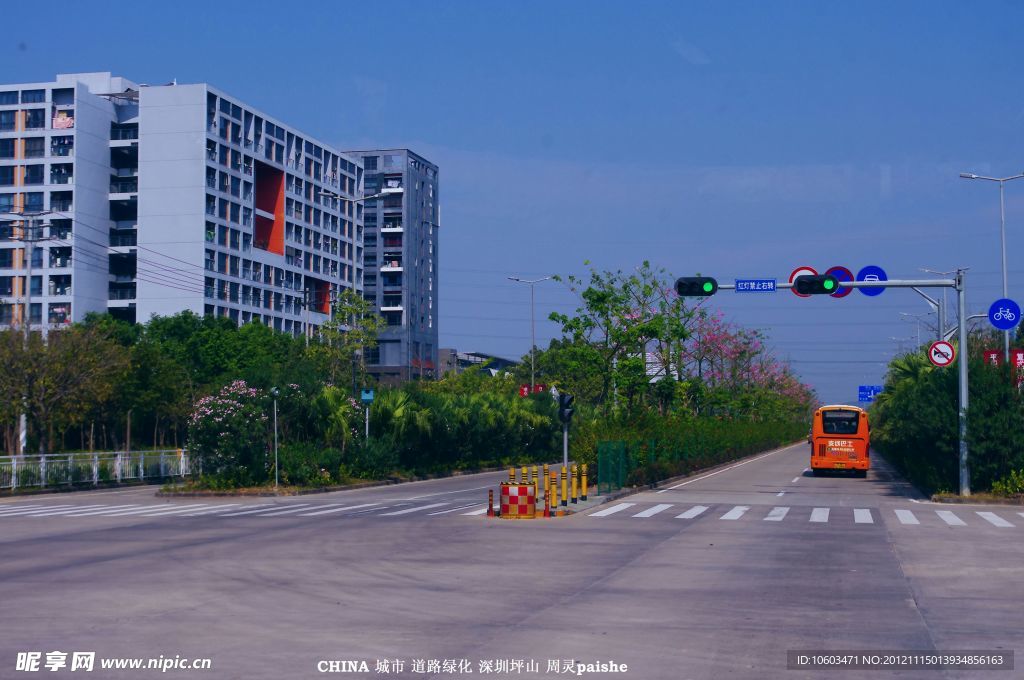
[{"xmin": 0, "ymin": 501, "xmax": 487, "ymax": 524}]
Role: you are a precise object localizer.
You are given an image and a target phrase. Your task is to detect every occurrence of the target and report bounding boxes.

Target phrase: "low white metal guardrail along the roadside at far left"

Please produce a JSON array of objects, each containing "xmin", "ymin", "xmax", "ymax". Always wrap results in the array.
[{"xmin": 0, "ymin": 449, "xmax": 193, "ymax": 491}]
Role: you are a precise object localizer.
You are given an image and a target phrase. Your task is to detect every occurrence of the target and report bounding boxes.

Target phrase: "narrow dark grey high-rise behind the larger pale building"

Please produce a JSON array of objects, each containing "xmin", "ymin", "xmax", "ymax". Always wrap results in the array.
[{"xmin": 349, "ymin": 148, "xmax": 440, "ymax": 383}]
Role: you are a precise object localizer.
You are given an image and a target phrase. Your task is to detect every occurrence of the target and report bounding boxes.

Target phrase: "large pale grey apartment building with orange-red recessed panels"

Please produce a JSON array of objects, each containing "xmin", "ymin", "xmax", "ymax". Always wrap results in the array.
[{"xmin": 0, "ymin": 73, "xmax": 364, "ymax": 335}]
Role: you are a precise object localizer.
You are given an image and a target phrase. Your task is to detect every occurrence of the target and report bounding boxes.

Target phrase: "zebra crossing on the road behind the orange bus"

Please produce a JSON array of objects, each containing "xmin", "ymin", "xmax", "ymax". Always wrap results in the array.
[{"xmin": 586, "ymin": 503, "xmax": 1024, "ymax": 528}]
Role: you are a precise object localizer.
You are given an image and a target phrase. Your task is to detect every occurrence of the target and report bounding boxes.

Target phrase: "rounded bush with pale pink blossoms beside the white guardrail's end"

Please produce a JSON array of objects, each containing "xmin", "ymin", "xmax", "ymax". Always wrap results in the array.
[{"xmin": 188, "ymin": 380, "xmax": 268, "ymax": 484}]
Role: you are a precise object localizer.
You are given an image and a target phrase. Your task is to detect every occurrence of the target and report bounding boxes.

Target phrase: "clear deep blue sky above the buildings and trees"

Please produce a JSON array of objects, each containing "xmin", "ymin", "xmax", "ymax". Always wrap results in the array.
[{"xmin": 0, "ymin": 0, "xmax": 1024, "ymax": 401}]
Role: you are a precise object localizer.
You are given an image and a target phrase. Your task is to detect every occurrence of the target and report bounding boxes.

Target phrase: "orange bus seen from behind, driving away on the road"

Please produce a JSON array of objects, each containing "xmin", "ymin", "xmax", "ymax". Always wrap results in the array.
[{"xmin": 811, "ymin": 406, "xmax": 871, "ymax": 477}]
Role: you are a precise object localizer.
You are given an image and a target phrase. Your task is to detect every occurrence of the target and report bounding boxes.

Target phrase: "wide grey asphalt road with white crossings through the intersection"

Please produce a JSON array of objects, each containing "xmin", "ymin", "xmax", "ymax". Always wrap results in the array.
[{"xmin": 0, "ymin": 444, "xmax": 1024, "ymax": 680}]
